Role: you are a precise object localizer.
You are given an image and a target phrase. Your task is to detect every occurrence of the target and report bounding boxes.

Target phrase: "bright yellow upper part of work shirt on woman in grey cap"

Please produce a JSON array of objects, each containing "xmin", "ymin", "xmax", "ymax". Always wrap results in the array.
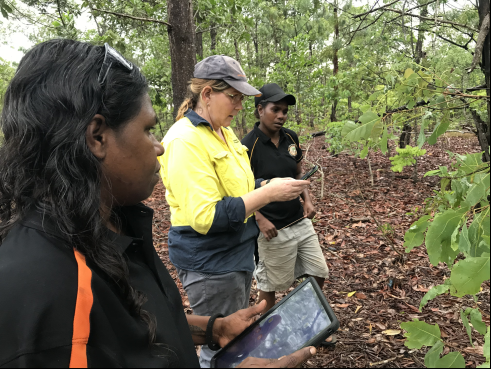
[{"xmin": 159, "ymin": 111, "xmax": 255, "ymax": 235}]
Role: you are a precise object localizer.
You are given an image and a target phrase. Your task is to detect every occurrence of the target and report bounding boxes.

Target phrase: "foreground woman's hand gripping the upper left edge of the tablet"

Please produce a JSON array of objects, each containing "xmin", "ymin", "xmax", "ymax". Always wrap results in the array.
[{"xmin": 213, "ymin": 300, "xmax": 266, "ymax": 347}]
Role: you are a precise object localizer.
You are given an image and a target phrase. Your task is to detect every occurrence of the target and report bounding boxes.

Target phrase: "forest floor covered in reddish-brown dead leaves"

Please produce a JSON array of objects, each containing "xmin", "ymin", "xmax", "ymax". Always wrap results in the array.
[{"xmin": 142, "ymin": 137, "xmax": 490, "ymax": 368}]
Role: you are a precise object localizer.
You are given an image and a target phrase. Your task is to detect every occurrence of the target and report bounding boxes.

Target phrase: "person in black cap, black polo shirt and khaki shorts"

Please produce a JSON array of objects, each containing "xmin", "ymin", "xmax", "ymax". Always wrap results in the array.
[{"xmin": 242, "ymin": 83, "xmax": 328, "ymax": 312}]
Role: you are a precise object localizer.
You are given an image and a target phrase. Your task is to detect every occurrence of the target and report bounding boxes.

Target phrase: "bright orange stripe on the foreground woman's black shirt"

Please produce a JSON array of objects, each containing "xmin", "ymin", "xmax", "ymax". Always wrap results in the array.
[{"xmin": 70, "ymin": 250, "xmax": 94, "ymax": 368}]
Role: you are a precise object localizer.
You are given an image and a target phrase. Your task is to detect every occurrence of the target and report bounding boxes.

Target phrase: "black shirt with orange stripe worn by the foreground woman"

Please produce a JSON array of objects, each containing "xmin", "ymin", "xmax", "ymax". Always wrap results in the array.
[{"xmin": 0, "ymin": 205, "xmax": 199, "ymax": 368}]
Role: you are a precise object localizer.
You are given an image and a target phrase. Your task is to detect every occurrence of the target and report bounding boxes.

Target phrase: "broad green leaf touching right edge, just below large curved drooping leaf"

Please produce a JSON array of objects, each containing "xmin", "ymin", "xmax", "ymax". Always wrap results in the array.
[{"xmin": 450, "ymin": 255, "xmax": 490, "ymax": 297}]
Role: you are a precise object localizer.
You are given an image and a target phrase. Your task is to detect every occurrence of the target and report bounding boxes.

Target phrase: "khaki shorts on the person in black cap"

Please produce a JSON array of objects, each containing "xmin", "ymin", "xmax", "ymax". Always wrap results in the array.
[{"xmin": 254, "ymin": 219, "xmax": 328, "ymax": 292}]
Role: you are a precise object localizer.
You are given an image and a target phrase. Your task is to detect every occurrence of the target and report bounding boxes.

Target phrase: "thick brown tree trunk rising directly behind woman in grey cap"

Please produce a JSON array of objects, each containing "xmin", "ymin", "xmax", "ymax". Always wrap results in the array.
[{"xmin": 167, "ymin": 0, "xmax": 196, "ymax": 119}]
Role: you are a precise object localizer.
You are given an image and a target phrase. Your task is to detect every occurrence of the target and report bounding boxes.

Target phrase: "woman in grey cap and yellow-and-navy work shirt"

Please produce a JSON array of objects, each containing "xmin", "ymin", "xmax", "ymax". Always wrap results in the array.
[{"xmin": 159, "ymin": 55, "xmax": 309, "ymax": 367}]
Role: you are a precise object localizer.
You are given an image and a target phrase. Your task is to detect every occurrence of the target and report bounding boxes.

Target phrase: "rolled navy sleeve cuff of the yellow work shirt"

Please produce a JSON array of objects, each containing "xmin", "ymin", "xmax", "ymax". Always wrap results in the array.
[{"xmin": 207, "ymin": 197, "xmax": 246, "ymax": 234}]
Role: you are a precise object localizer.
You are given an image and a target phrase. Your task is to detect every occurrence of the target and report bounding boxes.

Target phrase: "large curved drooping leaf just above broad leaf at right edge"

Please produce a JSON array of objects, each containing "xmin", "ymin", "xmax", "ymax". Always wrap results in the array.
[{"xmin": 425, "ymin": 208, "xmax": 467, "ymax": 265}]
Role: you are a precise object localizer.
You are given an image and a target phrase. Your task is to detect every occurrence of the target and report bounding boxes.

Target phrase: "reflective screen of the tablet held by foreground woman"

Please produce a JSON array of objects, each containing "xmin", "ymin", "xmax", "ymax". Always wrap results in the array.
[{"xmin": 216, "ymin": 283, "xmax": 331, "ymax": 368}]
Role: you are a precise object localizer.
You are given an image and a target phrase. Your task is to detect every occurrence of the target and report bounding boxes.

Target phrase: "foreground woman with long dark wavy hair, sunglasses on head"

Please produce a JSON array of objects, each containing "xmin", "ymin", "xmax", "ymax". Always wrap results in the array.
[{"xmin": 0, "ymin": 40, "xmax": 311, "ymax": 367}]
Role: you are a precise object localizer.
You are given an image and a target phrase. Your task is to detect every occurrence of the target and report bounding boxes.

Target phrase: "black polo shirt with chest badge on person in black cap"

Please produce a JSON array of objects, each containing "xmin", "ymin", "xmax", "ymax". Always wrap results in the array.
[{"xmin": 241, "ymin": 123, "xmax": 304, "ymax": 229}]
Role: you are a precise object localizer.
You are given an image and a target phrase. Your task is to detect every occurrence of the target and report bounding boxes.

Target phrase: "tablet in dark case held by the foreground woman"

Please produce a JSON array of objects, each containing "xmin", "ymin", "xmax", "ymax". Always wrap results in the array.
[{"xmin": 211, "ymin": 277, "xmax": 340, "ymax": 368}]
